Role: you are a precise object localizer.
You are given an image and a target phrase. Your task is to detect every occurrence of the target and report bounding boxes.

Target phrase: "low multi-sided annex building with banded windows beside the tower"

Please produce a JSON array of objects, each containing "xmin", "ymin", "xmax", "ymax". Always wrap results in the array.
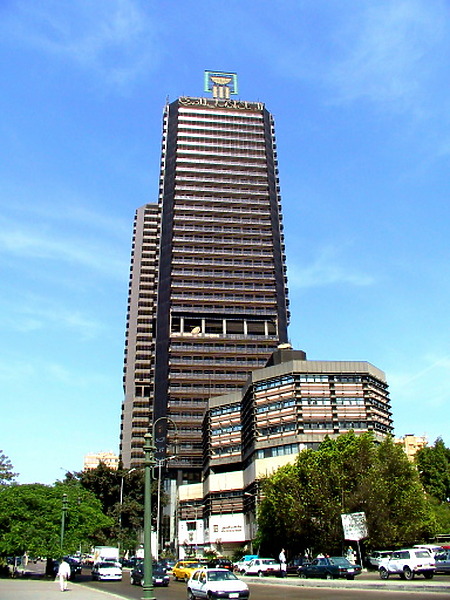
[{"xmin": 178, "ymin": 348, "xmax": 393, "ymax": 557}]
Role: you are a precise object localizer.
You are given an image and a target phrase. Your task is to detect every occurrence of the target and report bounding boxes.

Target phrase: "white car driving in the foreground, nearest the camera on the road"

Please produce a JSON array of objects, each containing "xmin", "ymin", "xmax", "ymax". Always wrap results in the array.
[{"xmin": 187, "ymin": 569, "xmax": 250, "ymax": 600}]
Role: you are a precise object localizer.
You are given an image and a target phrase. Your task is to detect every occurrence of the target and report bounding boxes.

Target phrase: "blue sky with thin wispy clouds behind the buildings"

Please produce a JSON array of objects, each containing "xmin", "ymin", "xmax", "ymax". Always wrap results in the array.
[{"xmin": 0, "ymin": 0, "xmax": 450, "ymax": 483}]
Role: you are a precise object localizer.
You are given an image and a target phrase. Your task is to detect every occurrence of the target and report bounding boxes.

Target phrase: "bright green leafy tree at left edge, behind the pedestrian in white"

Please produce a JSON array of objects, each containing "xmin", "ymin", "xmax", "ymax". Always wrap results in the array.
[{"xmin": 0, "ymin": 483, "xmax": 110, "ymax": 558}]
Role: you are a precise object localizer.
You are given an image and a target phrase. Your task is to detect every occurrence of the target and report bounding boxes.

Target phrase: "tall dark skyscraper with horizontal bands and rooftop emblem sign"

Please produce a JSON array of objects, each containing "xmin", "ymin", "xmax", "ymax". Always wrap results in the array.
[{"xmin": 120, "ymin": 71, "xmax": 289, "ymax": 483}]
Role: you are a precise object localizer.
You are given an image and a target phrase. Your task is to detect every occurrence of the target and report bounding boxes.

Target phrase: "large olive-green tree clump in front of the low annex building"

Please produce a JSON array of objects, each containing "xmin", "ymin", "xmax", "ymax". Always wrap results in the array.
[{"xmin": 257, "ymin": 432, "xmax": 436, "ymax": 555}]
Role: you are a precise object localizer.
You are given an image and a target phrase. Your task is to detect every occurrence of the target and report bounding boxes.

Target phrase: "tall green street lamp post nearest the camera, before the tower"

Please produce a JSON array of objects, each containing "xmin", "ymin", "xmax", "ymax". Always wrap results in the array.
[{"xmin": 142, "ymin": 432, "xmax": 156, "ymax": 600}]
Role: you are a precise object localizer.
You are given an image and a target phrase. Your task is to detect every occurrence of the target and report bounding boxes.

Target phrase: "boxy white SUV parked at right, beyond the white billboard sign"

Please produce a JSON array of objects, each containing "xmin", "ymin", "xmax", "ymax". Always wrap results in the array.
[{"xmin": 378, "ymin": 548, "xmax": 436, "ymax": 579}]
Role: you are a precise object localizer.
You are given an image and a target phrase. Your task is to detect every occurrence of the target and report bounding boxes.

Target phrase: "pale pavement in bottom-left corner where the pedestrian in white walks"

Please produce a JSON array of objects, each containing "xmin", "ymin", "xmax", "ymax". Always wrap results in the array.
[{"xmin": 0, "ymin": 578, "xmax": 128, "ymax": 600}]
